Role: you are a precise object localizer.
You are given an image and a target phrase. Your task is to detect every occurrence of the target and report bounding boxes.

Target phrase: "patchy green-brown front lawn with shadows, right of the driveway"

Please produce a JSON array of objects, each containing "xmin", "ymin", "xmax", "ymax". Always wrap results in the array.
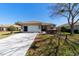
[{"xmin": 26, "ymin": 33, "xmax": 79, "ymax": 56}]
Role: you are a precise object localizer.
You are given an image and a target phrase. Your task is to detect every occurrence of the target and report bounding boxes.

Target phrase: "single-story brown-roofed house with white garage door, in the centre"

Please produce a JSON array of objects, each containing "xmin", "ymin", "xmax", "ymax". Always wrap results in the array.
[{"xmin": 17, "ymin": 21, "xmax": 56, "ymax": 32}]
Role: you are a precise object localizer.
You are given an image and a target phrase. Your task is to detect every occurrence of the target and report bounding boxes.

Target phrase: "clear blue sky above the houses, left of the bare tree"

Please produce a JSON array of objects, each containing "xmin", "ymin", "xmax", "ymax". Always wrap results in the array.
[{"xmin": 0, "ymin": 3, "xmax": 66, "ymax": 25}]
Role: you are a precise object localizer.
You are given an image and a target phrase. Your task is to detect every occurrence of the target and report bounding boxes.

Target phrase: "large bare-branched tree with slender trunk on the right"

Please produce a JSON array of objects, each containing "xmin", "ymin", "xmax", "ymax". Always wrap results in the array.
[{"xmin": 51, "ymin": 3, "xmax": 79, "ymax": 35}]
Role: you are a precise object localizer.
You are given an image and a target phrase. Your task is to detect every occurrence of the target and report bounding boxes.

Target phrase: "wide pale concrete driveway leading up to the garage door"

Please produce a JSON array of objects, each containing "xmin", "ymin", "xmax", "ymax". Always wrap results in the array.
[{"xmin": 0, "ymin": 33, "xmax": 37, "ymax": 56}]
